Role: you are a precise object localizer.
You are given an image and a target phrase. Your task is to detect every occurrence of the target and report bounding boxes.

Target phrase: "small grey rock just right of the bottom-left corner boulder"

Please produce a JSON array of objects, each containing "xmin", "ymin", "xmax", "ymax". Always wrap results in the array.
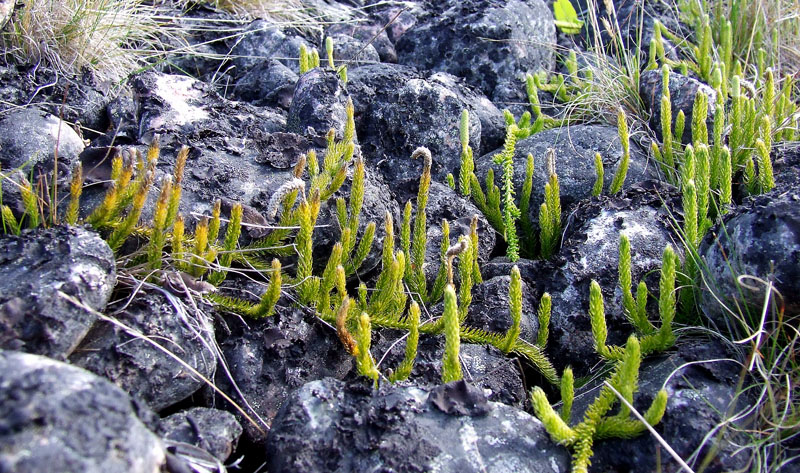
[{"xmin": 158, "ymin": 407, "xmax": 242, "ymax": 461}]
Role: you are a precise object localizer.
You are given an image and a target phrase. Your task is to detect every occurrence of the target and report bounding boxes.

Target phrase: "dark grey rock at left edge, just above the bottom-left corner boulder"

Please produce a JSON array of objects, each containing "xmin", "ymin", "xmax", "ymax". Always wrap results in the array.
[{"xmin": 0, "ymin": 227, "xmax": 116, "ymax": 359}]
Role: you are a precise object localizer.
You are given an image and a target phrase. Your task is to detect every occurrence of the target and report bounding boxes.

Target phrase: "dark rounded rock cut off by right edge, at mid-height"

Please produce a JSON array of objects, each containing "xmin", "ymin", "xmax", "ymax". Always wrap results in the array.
[{"xmin": 699, "ymin": 187, "xmax": 800, "ymax": 331}]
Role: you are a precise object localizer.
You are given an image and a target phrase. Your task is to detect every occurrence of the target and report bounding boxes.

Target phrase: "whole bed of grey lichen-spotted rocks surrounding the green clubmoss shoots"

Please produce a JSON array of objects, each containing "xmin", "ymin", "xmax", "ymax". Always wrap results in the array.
[{"xmin": 0, "ymin": 0, "xmax": 800, "ymax": 473}]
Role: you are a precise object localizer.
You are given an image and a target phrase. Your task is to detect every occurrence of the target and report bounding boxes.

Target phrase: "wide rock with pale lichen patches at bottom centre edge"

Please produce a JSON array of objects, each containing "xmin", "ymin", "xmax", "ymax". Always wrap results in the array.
[{"xmin": 267, "ymin": 378, "xmax": 569, "ymax": 473}]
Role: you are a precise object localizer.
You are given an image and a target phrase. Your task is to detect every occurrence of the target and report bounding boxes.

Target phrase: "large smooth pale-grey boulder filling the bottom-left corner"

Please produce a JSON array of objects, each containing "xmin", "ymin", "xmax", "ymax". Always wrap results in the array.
[{"xmin": 0, "ymin": 350, "xmax": 166, "ymax": 473}]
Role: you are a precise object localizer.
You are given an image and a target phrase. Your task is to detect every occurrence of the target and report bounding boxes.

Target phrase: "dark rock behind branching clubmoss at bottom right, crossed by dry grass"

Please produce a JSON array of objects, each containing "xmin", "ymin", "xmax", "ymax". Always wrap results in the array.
[{"xmin": 572, "ymin": 339, "xmax": 753, "ymax": 473}]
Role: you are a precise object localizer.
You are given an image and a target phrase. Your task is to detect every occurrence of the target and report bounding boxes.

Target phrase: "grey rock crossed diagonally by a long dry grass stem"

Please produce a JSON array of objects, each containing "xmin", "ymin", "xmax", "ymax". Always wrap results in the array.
[{"xmin": 69, "ymin": 291, "xmax": 216, "ymax": 411}]
